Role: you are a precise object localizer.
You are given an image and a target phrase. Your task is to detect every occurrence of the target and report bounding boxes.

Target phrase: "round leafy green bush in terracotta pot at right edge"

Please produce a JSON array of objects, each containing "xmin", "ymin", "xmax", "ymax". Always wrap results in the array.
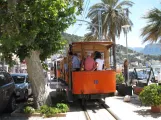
[{"xmin": 139, "ymin": 84, "xmax": 161, "ymax": 113}]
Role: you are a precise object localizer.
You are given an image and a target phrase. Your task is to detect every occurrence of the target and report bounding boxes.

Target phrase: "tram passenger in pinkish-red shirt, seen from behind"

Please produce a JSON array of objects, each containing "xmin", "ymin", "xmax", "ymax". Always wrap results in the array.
[{"xmin": 84, "ymin": 53, "xmax": 96, "ymax": 71}]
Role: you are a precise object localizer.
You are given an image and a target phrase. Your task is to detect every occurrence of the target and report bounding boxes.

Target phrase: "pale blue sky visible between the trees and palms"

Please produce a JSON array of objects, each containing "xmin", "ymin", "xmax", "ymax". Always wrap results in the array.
[{"xmin": 66, "ymin": 0, "xmax": 161, "ymax": 47}]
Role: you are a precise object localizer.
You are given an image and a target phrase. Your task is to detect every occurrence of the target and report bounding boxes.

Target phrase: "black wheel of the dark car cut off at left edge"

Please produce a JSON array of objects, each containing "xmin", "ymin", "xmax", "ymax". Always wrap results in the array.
[{"xmin": 7, "ymin": 95, "xmax": 16, "ymax": 112}]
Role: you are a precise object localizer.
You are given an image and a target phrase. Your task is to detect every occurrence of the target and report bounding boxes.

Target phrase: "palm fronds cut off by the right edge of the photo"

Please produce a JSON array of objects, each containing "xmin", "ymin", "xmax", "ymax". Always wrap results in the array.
[{"xmin": 141, "ymin": 8, "xmax": 161, "ymax": 43}]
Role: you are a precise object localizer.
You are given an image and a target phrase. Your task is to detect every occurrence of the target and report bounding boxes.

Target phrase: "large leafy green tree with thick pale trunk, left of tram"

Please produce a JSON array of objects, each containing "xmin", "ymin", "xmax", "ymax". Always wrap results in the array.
[{"xmin": 0, "ymin": 0, "xmax": 82, "ymax": 107}]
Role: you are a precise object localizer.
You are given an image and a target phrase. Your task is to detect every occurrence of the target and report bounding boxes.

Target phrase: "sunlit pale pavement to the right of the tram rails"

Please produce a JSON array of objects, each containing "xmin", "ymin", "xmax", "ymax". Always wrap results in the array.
[{"xmin": 106, "ymin": 96, "xmax": 161, "ymax": 120}]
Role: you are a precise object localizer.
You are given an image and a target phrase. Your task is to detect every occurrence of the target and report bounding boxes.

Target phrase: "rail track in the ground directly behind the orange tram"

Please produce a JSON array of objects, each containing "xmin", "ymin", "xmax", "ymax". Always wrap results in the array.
[{"xmin": 81, "ymin": 100, "xmax": 120, "ymax": 120}]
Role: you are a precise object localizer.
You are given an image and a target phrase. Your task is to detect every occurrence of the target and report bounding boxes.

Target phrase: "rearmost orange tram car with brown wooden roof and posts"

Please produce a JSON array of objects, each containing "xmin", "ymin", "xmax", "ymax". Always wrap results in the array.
[{"xmin": 62, "ymin": 41, "xmax": 116, "ymax": 100}]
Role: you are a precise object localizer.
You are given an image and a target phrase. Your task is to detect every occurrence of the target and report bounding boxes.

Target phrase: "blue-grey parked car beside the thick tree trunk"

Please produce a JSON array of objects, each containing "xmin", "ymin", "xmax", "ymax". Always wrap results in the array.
[{"xmin": 11, "ymin": 73, "xmax": 32, "ymax": 101}]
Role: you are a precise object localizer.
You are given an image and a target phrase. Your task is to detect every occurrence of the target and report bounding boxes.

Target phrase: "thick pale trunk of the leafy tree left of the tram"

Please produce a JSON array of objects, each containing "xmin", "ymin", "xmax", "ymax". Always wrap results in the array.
[{"xmin": 25, "ymin": 51, "xmax": 51, "ymax": 108}]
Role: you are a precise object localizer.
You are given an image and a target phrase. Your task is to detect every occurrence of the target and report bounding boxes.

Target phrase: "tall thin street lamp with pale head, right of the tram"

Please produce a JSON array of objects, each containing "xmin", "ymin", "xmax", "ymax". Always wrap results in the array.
[{"xmin": 122, "ymin": 25, "xmax": 130, "ymax": 82}]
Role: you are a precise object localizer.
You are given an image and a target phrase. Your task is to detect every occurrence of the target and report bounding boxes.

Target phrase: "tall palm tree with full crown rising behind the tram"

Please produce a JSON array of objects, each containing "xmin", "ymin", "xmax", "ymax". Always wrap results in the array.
[{"xmin": 87, "ymin": 0, "xmax": 133, "ymax": 68}]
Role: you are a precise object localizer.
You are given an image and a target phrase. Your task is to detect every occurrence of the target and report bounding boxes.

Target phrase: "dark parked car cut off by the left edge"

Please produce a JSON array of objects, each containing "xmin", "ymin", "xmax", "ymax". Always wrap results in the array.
[{"xmin": 0, "ymin": 70, "xmax": 16, "ymax": 112}]
